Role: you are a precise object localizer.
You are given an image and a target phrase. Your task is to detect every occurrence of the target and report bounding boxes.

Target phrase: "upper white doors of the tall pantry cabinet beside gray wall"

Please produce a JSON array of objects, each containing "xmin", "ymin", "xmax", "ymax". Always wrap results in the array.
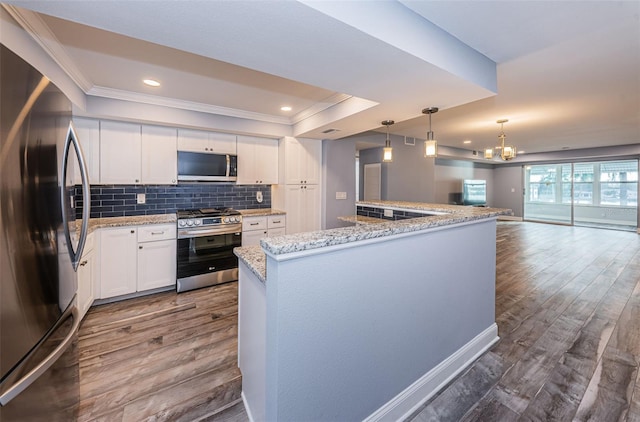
[{"xmin": 280, "ymin": 136, "xmax": 322, "ymax": 185}]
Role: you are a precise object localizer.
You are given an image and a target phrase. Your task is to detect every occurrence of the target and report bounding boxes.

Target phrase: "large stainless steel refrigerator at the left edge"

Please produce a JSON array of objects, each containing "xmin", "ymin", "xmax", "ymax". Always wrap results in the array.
[{"xmin": 0, "ymin": 44, "xmax": 90, "ymax": 422}]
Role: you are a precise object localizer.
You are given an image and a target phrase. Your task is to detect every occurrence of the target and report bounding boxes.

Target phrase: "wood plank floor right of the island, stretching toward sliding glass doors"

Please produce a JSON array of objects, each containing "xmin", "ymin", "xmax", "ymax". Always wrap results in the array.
[{"xmin": 409, "ymin": 222, "xmax": 640, "ymax": 422}]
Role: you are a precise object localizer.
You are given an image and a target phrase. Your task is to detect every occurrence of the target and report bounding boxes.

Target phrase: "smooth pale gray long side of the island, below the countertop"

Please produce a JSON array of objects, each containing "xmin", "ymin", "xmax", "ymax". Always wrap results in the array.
[{"xmin": 262, "ymin": 220, "xmax": 497, "ymax": 421}]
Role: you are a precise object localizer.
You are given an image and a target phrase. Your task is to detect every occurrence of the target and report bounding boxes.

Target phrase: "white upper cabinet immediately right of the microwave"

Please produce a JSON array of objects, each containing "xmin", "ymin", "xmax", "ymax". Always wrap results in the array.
[{"xmin": 236, "ymin": 136, "xmax": 278, "ymax": 185}]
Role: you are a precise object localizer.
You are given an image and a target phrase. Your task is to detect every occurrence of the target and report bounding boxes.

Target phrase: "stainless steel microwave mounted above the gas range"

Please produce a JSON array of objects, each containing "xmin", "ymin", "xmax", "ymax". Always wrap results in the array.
[{"xmin": 178, "ymin": 151, "xmax": 238, "ymax": 182}]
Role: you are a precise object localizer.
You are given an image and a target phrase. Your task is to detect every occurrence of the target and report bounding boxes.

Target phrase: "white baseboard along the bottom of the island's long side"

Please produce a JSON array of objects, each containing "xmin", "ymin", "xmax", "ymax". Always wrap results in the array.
[{"xmin": 362, "ymin": 323, "xmax": 499, "ymax": 422}]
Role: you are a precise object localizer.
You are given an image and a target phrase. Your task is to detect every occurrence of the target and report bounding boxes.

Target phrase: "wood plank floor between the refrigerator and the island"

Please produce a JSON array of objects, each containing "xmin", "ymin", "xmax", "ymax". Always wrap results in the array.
[{"xmin": 78, "ymin": 283, "xmax": 247, "ymax": 422}]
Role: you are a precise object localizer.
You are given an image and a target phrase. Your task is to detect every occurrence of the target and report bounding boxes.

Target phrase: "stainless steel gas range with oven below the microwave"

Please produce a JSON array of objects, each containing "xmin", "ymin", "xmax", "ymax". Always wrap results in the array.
[{"xmin": 177, "ymin": 208, "xmax": 242, "ymax": 292}]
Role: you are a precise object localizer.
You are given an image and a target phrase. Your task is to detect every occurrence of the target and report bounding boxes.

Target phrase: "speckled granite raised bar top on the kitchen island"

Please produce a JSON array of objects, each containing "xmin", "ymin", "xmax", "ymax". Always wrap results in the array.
[{"xmin": 260, "ymin": 201, "xmax": 513, "ymax": 255}]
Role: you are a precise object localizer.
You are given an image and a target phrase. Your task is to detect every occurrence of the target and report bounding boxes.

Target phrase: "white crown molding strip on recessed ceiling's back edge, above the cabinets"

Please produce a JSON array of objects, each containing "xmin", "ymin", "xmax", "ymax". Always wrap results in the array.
[{"xmin": 87, "ymin": 86, "xmax": 291, "ymax": 125}]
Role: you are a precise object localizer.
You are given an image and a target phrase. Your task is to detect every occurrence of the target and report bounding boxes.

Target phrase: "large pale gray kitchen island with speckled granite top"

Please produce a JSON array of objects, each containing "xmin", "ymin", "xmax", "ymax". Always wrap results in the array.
[{"xmin": 236, "ymin": 201, "xmax": 510, "ymax": 421}]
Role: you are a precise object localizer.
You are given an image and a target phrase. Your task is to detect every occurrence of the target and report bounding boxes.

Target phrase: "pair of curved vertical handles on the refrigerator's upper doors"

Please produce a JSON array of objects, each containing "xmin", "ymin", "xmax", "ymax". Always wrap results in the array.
[{"xmin": 60, "ymin": 122, "xmax": 91, "ymax": 271}]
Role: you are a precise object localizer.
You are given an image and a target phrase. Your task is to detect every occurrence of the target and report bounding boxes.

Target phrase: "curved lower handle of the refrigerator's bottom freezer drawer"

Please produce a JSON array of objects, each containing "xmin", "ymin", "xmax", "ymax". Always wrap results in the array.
[{"xmin": 0, "ymin": 298, "xmax": 80, "ymax": 406}]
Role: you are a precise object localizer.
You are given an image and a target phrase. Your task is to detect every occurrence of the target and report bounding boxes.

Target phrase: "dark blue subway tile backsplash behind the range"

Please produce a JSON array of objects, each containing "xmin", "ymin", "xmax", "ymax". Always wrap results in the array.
[{"xmin": 75, "ymin": 183, "xmax": 271, "ymax": 218}]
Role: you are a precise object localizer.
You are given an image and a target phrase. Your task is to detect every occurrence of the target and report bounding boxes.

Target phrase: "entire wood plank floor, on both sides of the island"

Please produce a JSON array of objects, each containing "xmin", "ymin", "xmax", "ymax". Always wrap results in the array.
[{"xmin": 79, "ymin": 222, "xmax": 640, "ymax": 422}]
